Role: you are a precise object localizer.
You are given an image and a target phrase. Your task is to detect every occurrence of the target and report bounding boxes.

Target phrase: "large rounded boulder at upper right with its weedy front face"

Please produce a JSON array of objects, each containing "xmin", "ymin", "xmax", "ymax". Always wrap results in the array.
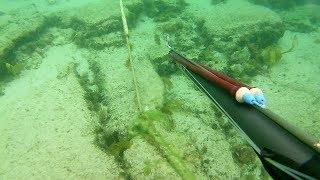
[{"xmin": 184, "ymin": 0, "xmax": 285, "ymax": 78}]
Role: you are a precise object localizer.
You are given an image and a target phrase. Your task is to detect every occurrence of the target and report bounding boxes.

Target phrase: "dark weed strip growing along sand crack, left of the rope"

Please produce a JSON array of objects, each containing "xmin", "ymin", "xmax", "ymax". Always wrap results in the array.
[{"xmin": 74, "ymin": 57, "xmax": 132, "ymax": 179}]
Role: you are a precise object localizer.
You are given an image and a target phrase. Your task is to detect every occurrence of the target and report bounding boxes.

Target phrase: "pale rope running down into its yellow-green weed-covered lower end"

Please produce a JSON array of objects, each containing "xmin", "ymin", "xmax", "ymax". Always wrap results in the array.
[{"xmin": 120, "ymin": 0, "xmax": 194, "ymax": 179}]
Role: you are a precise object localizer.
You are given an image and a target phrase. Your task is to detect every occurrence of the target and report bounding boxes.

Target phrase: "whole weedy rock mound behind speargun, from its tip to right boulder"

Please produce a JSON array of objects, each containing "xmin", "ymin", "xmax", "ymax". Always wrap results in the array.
[{"xmin": 158, "ymin": 0, "xmax": 285, "ymax": 79}]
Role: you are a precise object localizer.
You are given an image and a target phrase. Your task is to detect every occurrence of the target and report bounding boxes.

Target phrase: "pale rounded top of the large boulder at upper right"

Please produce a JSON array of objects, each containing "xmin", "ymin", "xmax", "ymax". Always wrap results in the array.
[{"xmin": 199, "ymin": 1, "xmax": 284, "ymax": 51}]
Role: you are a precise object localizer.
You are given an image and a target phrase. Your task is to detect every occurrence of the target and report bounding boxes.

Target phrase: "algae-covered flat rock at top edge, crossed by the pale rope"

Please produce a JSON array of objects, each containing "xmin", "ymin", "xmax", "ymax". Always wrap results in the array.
[{"xmin": 57, "ymin": 0, "xmax": 143, "ymax": 28}]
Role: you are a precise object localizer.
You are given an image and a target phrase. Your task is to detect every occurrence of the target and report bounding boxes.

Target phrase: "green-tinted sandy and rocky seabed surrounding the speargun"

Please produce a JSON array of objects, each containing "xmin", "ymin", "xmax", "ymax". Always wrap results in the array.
[{"xmin": 0, "ymin": 0, "xmax": 320, "ymax": 179}]
